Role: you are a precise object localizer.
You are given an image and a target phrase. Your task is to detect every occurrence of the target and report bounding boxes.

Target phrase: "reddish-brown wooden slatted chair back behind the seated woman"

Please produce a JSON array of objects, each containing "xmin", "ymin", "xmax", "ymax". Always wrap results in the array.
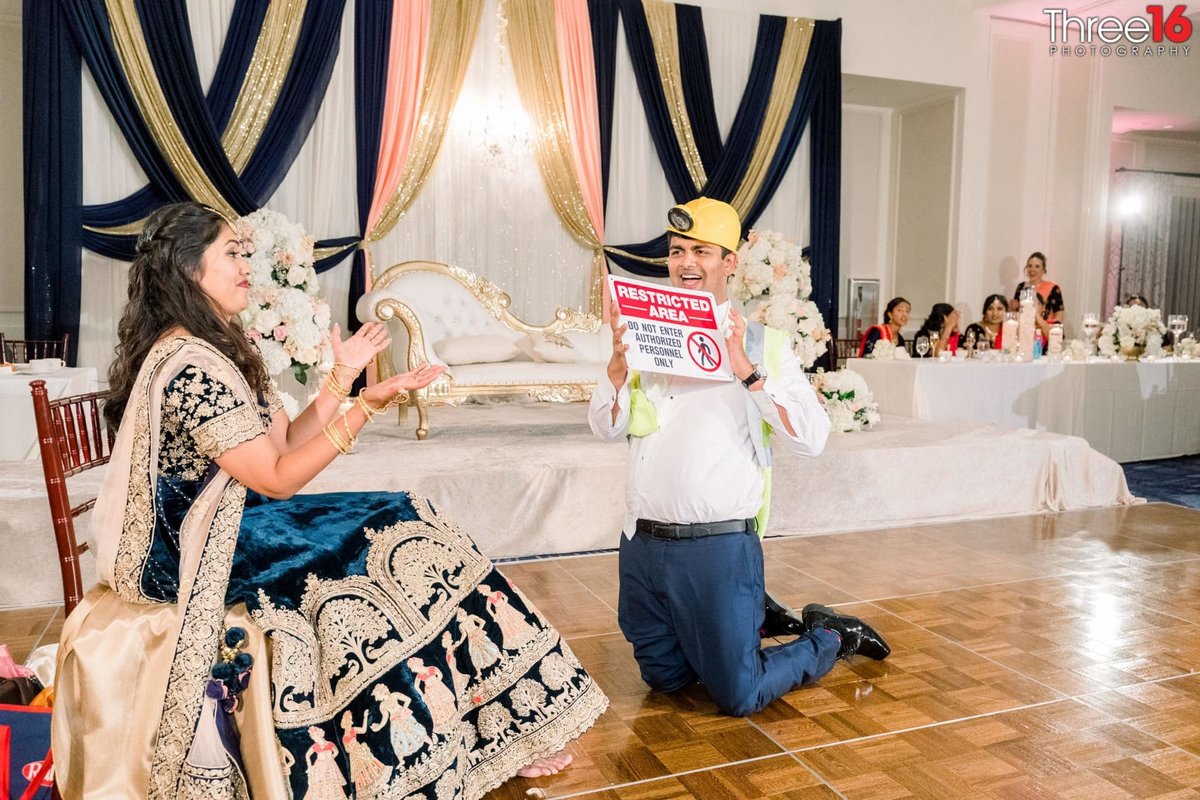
[{"xmin": 30, "ymin": 380, "xmax": 113, "ymax": 614}]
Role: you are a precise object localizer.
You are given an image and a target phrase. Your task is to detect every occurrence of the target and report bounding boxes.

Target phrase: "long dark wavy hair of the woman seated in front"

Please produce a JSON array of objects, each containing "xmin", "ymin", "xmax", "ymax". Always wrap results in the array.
[{"xmin": 104, "ymin": 203, "xmax": 269, "ymax": 428}]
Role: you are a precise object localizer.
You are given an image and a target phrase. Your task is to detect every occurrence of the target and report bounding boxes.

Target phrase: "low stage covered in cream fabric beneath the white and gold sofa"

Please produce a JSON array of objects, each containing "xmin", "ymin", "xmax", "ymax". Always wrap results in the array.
[{"xmin": 0, "ymin": 403, "xmax": 1134, "ymax": 607}]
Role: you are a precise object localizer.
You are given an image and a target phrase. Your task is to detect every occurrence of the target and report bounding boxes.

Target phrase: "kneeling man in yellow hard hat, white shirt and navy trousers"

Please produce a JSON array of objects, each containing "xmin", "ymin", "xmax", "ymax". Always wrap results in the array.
[{"xmin": 589, "ymin": 198, "xmax": 890, "ymax": 716}]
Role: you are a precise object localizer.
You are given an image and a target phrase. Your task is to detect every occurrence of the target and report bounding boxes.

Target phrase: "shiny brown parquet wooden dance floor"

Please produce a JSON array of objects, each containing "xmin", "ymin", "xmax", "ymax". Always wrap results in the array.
[{"xmin": 7, "ymin": 504, "xmax": 1200, "ymax": 800}]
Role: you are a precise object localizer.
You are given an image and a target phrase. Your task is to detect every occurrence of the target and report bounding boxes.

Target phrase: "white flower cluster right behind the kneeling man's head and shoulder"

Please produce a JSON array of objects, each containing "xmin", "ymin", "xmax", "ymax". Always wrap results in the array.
[{"xmin": 730, "ymin": 230, "xmax": 830, "ymax": 368}]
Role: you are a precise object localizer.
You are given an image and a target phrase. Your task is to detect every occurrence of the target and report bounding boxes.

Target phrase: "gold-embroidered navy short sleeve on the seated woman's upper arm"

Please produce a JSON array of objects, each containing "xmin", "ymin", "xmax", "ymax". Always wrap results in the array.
[{"xmin": 163, "ymin": 366, "xmax": 266, "ymax": 459}]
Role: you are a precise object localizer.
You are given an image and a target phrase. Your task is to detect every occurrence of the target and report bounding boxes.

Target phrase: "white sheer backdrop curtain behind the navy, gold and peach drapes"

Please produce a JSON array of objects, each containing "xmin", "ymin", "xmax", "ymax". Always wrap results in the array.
[{"xmin": 79, "ymin": 0, "xmax": 809, "ymax": 373}]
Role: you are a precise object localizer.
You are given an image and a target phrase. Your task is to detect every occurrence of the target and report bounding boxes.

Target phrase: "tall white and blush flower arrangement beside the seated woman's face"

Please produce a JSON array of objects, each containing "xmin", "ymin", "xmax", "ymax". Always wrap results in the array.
[{"xmin": 235, "ymin": 209, "xmax": 332, "ymax": 384}]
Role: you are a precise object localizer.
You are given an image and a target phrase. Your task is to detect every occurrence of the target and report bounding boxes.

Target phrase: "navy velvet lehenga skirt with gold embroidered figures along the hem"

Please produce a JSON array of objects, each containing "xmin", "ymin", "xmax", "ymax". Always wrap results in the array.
[{"xmin": 227, "ymin": 492, "xmax": 607, "ymax": 800}]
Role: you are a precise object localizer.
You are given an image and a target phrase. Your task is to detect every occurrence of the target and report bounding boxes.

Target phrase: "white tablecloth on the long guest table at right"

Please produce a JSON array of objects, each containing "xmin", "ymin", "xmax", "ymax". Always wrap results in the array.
[{"xmin": 847, "ymin": 359, "xmax": 1200, "ymax": 462}]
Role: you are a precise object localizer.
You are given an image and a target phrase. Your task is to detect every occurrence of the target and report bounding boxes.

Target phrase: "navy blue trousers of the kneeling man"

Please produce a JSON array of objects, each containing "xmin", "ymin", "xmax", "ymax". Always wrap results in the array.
[{"xmin": 617, "ymin": 533, "xmax": 840, "ymax": 716}]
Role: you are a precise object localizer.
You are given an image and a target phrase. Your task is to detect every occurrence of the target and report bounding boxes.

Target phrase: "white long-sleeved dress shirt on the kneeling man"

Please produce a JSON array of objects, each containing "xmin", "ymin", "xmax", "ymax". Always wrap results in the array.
[{"xmin": 588, "ymin": 302, "xmax": 829, "ymax": 536}]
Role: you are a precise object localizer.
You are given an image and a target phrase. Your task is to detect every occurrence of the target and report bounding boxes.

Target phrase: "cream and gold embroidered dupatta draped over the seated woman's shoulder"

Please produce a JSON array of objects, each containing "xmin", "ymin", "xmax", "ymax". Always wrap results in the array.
[{"xmin": 53, "ymin": 337, "xmax": 288, "ymax": 799}]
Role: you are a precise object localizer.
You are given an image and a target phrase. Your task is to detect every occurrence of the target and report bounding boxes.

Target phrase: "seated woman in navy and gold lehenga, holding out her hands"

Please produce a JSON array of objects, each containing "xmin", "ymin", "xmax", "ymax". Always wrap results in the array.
[{"xmin": 53, "ymin": 203, "xmax": 607, "ymax": 800}]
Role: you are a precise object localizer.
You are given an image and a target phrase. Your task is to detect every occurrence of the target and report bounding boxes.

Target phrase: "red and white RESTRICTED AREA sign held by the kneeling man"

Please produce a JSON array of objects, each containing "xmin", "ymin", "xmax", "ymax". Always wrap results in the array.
[{"xmin": 608, "ymin": 275, "xmax": 733, "ymax": 380}]
